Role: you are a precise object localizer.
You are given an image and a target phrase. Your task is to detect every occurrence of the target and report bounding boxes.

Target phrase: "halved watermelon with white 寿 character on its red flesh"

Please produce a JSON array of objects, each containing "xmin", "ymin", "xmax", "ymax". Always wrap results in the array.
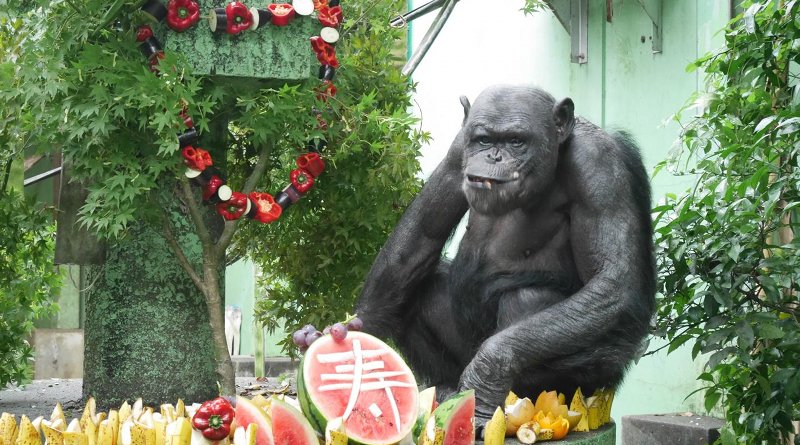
[{"xmin": 297, "ymin": 332, "xmax": 419, "ymax": 445}]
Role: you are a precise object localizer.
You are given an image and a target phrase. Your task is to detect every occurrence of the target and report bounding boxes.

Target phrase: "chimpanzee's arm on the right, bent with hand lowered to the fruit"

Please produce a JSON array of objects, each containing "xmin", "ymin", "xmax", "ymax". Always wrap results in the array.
[{"xmin": 459, "ymin": 129, "xmax": 655, "ymax": 423}]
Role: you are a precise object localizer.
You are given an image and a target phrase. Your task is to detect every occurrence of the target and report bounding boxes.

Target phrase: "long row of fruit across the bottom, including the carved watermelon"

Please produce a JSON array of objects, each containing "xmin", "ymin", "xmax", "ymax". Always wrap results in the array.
[{"xmin": 0, "ymin": 326, "xmax": 614, "ymax": 445}]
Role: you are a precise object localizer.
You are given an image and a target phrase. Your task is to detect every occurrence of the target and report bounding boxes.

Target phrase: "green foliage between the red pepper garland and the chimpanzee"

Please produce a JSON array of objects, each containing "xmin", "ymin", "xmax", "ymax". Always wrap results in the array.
[{"xmin": 248, "ymin": 0, "xmax": 427, "ymax": 354}]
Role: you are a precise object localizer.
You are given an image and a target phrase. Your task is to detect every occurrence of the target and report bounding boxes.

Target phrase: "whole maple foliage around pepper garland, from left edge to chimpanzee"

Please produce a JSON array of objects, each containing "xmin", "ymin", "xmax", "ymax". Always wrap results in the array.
[{"xmin": 0, "ymin": 0, "xmax": 426, "ymax": 360}]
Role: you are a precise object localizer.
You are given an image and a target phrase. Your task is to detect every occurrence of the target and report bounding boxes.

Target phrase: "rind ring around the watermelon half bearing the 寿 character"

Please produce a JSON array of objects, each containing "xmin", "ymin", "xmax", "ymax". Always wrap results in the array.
[{"xmin": 297, "ymin": 332, "xmax": 419, "ymax": 445}]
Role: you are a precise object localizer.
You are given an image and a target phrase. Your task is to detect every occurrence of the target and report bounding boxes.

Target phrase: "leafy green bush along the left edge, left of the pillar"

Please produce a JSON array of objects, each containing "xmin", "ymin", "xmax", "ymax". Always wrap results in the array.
[{"xmin": 0, "ymin": 9, "xmax": 60, "ymax": 388}]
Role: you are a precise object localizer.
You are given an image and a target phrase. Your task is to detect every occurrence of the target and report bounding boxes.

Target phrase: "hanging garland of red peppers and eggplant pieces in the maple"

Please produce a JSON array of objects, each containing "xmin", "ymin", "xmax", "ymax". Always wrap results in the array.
[{"xmin": 136, "ymin": 0, "xmax": 343, "ymax": 224}]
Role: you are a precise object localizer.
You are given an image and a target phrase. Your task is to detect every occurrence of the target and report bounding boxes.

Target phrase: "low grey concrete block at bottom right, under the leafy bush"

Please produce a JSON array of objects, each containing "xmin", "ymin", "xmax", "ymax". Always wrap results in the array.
[{"xmin": 622, "ymin": 413, "xmax": 725, "ymax": 445}]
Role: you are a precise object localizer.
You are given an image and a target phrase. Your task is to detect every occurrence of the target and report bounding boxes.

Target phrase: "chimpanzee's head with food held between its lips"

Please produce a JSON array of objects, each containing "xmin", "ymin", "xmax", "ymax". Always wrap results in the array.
[{"xmin": 461, "ymin": 86, "xmax": 575, "ymax": 215}]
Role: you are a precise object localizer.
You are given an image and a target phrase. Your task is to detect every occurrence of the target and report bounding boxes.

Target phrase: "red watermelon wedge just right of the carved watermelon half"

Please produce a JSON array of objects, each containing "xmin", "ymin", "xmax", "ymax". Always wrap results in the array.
[{"xmin": 418, "ymin": 389, "xmax": 475, "ymax": 445}]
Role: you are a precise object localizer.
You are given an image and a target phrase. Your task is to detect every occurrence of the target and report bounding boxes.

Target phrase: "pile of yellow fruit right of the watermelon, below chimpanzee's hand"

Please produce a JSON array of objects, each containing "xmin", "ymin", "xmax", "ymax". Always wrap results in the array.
[{"xmin": 484, "ymin": 388, "xmax": 614, "ymax": 445}]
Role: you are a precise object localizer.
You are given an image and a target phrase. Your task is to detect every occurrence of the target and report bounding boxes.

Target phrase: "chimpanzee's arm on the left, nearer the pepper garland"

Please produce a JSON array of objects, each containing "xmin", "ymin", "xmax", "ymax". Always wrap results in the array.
[{"xmin": 356, "ymin": 135, "xmax": 467, "ymax": 337}]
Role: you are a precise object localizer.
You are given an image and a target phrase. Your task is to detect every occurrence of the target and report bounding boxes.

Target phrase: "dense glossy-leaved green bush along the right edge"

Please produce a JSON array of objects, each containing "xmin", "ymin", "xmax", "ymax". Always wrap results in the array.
[{"xmin": 654, "ymin": 1, "xmax": 800, "ymax": 443}]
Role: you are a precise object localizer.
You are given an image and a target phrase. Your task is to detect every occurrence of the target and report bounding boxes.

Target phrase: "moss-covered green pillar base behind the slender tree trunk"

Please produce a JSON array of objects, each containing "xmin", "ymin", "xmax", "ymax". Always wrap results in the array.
[{"xmin": 83, "ymin": 204, "xmax": 217, "ymax": 406}]
